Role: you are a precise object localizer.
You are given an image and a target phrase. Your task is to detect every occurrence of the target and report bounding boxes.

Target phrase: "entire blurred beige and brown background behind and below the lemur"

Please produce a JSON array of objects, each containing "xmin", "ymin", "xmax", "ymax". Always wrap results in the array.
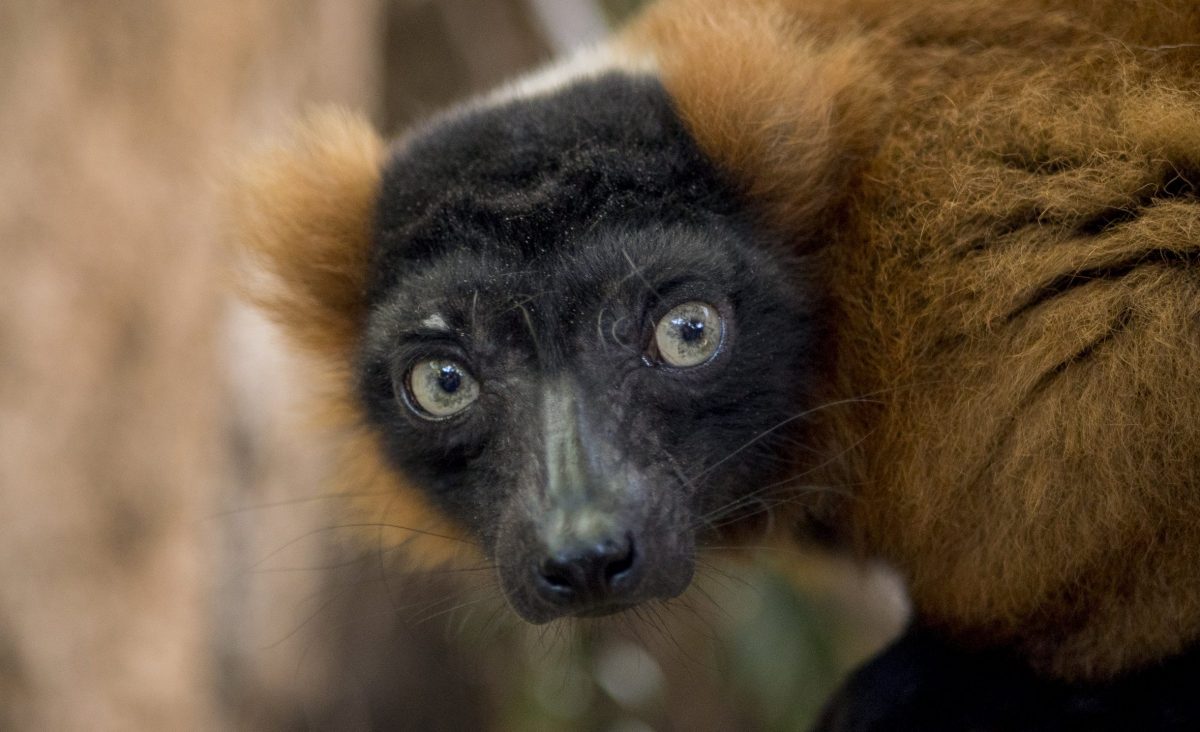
[{"xmin": 0, "ymin": 0, "xmax": 905, "ymax": 732}]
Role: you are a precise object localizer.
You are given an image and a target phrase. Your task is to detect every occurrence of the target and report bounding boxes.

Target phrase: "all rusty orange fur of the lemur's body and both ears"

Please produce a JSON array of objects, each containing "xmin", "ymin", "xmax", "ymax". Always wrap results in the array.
[{"xmin": 234, "ymin": 0, "xmax": 1200, "ymax": 679}]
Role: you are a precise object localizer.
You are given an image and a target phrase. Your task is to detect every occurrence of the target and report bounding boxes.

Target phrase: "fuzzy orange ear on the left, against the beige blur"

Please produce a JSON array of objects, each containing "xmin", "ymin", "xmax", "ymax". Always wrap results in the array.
[{"xmin": 229, "ymin": 109, "xmax": 386, "ymax": 364}]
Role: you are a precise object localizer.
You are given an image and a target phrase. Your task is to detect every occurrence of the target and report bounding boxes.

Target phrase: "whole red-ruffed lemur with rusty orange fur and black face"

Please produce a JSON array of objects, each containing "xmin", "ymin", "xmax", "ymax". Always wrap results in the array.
[{"xmin": 236, "ymin": 0, "xmax": 1200, "ymax": 730}]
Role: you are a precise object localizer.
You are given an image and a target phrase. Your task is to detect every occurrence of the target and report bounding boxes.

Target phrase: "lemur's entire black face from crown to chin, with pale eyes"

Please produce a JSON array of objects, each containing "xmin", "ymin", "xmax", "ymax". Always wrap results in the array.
[{"xmin": 359, "ymin": 73, "xmax": 820, "ymax": 623}]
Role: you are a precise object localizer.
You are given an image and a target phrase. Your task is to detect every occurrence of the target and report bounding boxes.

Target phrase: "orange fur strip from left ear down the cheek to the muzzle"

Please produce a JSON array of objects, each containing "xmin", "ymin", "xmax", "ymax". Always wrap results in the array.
[{"xmin": 232, "ymin": 109, "xmax": 478, "ymax": 564}]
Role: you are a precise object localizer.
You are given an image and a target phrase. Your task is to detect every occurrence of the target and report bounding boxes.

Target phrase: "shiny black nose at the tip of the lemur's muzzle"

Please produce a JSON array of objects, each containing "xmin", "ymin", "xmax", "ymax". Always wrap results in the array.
[{"xmin": 535, "ymin": 535, "xmax": 641, "ymax": 612}]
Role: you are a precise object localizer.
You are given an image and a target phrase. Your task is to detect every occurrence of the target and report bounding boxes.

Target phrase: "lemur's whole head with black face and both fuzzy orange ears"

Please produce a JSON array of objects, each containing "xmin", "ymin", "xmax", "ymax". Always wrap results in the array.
[{"xmin": 238, "ymin": 4, "xmax": 883, "ymax": 623}]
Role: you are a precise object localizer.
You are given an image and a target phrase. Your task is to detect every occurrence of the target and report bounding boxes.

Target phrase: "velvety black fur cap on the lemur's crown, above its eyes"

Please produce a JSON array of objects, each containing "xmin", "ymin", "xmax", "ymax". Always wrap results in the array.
[{"xmin": 368, "ymin": 73, "xmax": 737, "ymax": 298}]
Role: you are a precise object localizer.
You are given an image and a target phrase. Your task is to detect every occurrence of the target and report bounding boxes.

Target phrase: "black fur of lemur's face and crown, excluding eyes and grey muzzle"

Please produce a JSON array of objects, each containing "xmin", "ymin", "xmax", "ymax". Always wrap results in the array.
[{"xmin": 360, "ymin": 74, "xmax": 821, "ymax": 576}]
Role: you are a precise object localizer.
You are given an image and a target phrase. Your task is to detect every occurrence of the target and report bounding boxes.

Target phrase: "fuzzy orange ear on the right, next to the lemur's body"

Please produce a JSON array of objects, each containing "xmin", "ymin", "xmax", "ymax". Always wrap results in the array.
[{"xmin": 626, "ymin": 0, "xmax": 887, "ymax": 240}]
